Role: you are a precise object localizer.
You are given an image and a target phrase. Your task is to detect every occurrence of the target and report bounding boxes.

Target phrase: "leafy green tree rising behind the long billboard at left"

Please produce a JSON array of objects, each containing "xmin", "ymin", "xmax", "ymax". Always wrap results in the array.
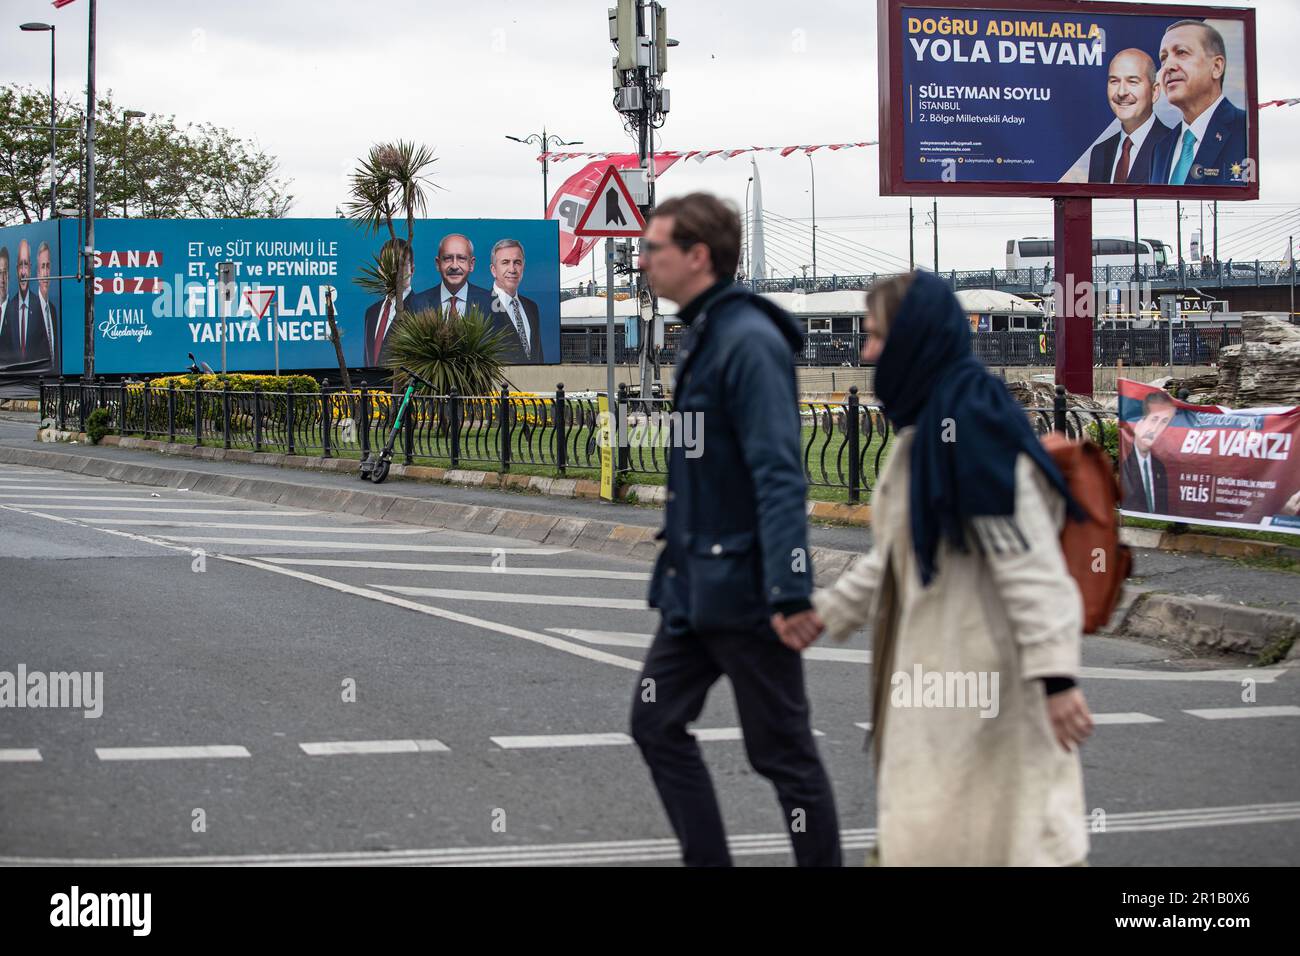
[{"xmin": 0, "ymin": 83, "xmax": 294, "ymax": 224}]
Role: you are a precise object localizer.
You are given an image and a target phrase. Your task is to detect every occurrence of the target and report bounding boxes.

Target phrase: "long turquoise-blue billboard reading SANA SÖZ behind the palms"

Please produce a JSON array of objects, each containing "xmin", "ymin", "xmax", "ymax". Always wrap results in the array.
[{"xmin": 32, "ymin": 219, "xmax": 560, "ymax": 375}]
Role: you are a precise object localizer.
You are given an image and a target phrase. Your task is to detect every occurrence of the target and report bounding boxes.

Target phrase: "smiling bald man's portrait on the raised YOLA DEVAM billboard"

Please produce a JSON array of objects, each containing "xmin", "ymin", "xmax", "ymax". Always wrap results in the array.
[{"xmin": 1088, "ymin": 48, "xmax": 1173, "ymax": 183}]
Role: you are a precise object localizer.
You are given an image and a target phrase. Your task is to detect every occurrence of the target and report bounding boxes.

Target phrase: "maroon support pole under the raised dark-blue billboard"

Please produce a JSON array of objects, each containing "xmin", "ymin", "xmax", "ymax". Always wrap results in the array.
[{"xmin": 1052, "ymin": 198, "xmax": 1096, "ymax": 397}]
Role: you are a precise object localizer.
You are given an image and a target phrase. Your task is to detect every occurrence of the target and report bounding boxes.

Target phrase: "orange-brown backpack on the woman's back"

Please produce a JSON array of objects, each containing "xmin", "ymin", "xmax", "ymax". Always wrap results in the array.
[{"xmin": 1043, "ymin": 432, "xmax": 1132, "ymax": 633}]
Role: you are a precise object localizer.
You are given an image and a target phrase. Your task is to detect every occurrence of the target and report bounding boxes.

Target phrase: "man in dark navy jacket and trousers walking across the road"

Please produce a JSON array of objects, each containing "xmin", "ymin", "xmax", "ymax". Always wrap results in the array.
[{"xmin": 632, "ymin": 193, "xmax": 841, "ymax": 866}]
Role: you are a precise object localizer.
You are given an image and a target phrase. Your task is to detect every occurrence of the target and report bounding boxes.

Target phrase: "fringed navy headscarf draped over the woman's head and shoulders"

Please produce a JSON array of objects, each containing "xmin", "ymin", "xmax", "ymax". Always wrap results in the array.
[{"xmin": 875, "ymin": 272, "xmax": 1082, "ymax": 584}]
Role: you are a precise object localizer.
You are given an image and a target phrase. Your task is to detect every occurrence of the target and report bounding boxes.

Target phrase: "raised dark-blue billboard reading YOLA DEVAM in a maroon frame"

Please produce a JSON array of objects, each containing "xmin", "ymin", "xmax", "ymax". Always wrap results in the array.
[{"xmin": 881, "ymin": 0, "xmax": 1258, "ymax": 199}]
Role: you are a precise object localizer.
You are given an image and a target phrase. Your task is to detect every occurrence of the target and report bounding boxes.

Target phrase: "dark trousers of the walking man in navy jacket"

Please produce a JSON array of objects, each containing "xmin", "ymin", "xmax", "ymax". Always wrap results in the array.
[{"xmin": 632, "ymin": 627, "xmax": 841, "ymax": 866}]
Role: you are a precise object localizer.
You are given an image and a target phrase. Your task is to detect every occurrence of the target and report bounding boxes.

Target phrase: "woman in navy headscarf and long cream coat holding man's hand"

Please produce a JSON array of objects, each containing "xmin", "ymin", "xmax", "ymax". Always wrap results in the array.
[{"xmin": 774, "ymin": 273, "xmax": 1092, "ymax": 866}]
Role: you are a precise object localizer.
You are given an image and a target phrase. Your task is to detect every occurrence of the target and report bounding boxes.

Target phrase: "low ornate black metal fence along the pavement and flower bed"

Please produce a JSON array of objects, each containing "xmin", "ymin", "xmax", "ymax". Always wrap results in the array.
[{"xmin": 40, "ymin": 381, "xmax": 1114, "ymax": 503}]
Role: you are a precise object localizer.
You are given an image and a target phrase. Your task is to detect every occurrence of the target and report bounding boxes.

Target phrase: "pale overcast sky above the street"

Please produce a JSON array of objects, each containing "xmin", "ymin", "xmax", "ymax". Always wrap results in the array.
[{"xmin": 0, "ymin": 0, "xmax": 1300, "ymax": 284}]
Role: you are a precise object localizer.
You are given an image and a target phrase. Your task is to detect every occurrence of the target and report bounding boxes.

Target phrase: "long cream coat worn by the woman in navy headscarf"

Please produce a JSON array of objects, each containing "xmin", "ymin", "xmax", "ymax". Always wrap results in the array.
[{"xmin": 813, "ymin": 429, "xmax": 1088, "ymax": 866}]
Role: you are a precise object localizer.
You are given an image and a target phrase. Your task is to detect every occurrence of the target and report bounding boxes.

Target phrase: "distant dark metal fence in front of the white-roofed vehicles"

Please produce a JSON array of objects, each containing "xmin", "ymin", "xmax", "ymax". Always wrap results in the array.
[{"xmin": 560, "ymin": 328, "xmax": 1242, "ymax": 368}]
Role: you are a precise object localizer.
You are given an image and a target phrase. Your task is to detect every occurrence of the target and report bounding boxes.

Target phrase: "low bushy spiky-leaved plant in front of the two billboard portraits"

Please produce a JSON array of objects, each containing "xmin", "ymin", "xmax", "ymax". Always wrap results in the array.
[{"xmin": 385, "ymin": 306, "xmax": 506, "ymax": 395}]
